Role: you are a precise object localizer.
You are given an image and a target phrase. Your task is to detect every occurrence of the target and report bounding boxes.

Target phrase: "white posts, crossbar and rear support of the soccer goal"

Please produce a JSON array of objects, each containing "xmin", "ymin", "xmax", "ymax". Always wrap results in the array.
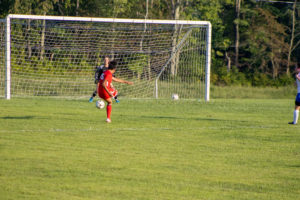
[{"xmin": 5, "ymin": 14, "xmax": 212, "ymax": 102}]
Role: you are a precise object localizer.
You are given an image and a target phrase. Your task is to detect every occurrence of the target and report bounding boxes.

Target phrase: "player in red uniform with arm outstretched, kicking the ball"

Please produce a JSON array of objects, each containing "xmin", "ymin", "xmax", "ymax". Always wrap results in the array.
[{"xmin": 98, "ymin": 61, "xmax": 133, "ymax": 123}]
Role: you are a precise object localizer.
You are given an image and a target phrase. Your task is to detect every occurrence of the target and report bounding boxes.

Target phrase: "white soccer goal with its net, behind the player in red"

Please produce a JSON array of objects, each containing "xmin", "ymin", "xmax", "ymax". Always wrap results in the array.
[{"xmin": 0, "ymin": 15, "xmax": 211, "ymax": 101}]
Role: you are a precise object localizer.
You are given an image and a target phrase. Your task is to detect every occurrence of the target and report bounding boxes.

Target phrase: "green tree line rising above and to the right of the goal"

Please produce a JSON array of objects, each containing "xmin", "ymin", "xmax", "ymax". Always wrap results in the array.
[{"xmin": 0, "ymin": 0, "xmax": 300, "ymax": 86}]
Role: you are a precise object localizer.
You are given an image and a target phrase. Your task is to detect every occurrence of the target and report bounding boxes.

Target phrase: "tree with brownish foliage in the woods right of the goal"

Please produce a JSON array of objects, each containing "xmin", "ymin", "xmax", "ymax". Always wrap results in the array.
[{"xmin": 247, "ymin": 8, "xmax": 288, "ymax": 79}]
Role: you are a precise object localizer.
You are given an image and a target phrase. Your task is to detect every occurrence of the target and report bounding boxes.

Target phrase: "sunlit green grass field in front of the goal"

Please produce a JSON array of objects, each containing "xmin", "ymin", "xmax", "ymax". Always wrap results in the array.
[{"xmin": 0, "ymin": 98, "xmax": 300, "ymax": 200}]
